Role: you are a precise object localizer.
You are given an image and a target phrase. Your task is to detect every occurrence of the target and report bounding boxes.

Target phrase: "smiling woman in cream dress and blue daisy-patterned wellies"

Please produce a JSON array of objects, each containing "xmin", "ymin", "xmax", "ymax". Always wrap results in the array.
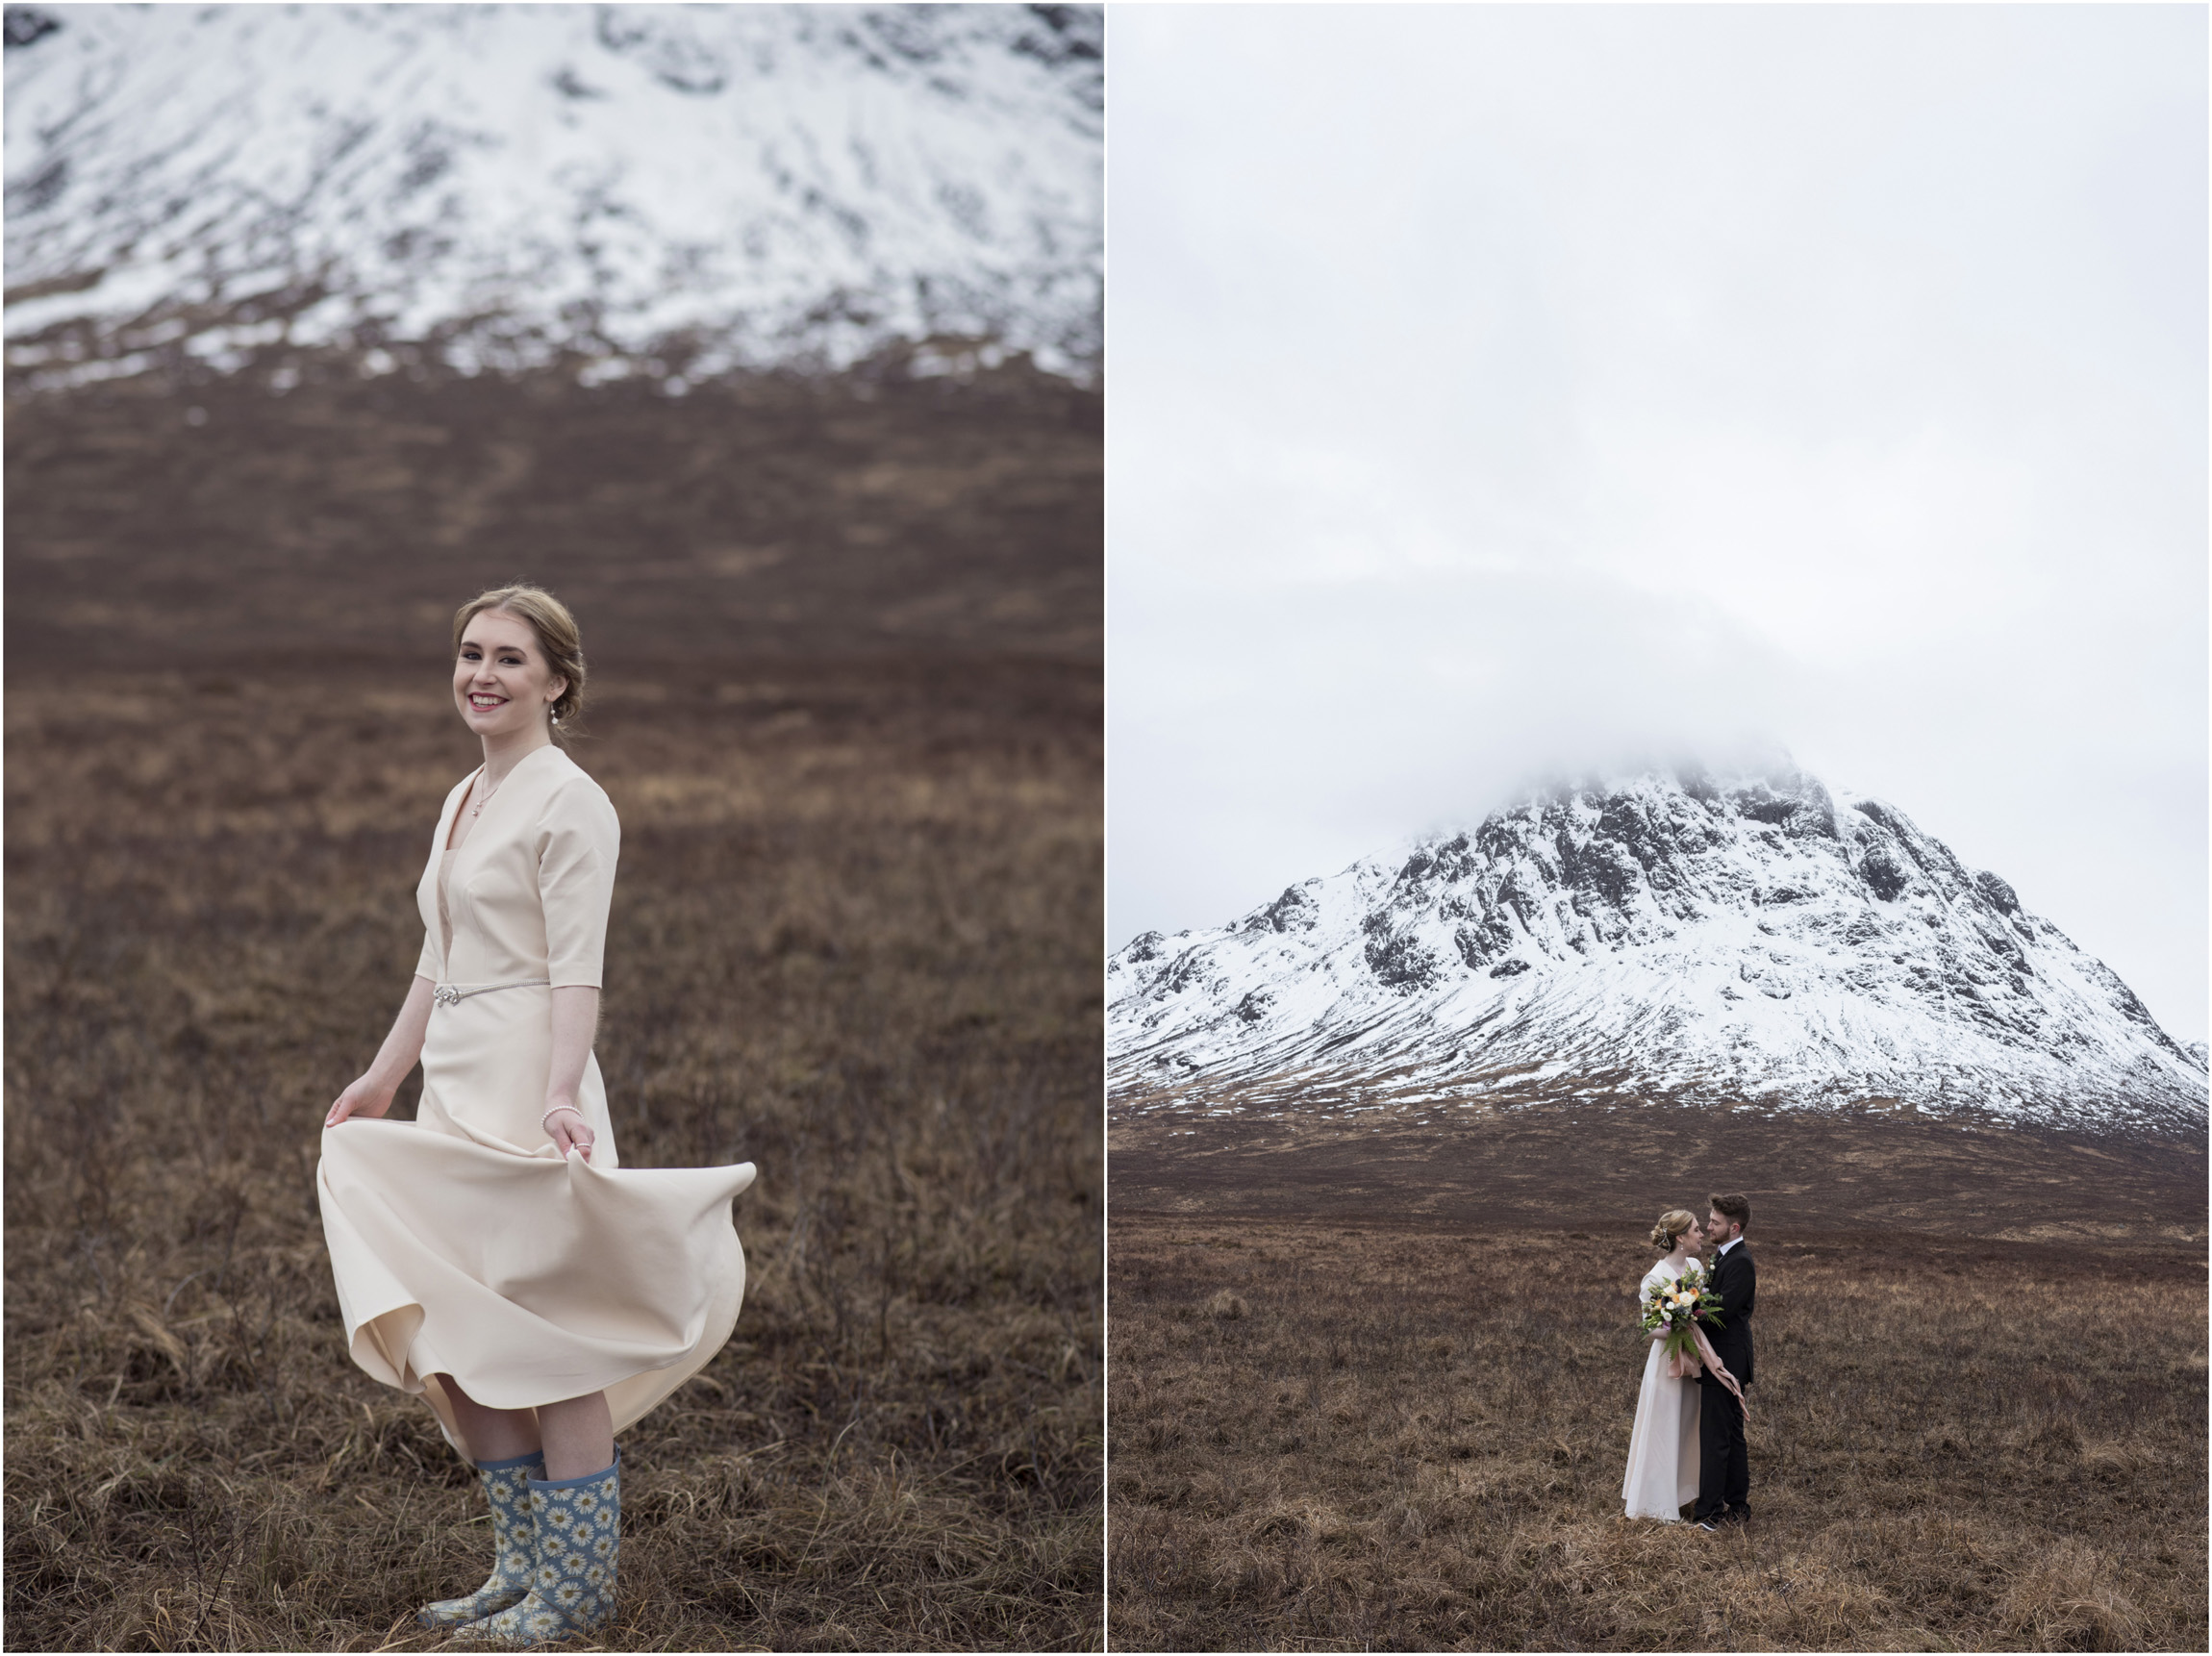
[{"xmin": 316, "ymin": 586, "xmax": 752, "ymax": 1645}]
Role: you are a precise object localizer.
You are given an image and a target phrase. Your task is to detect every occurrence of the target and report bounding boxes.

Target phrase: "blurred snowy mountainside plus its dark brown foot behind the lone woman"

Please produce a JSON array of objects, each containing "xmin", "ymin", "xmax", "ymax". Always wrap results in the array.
[{"xmin": 7, "ymin": 7, "xmax": 1104, "ymax": 665}]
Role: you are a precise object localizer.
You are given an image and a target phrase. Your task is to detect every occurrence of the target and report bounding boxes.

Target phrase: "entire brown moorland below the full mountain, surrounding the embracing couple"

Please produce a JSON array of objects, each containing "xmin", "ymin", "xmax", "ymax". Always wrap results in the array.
[{"xmin": 1108, "ymin": 1106, "xmax": 2207, "ymax": 1649}]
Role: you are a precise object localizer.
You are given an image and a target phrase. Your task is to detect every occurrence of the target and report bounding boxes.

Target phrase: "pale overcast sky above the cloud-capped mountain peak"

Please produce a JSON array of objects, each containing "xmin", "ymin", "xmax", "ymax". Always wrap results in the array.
[{"xmin": 1106, "ymin": 7, "xmax": 2207, "ymax": 1040}]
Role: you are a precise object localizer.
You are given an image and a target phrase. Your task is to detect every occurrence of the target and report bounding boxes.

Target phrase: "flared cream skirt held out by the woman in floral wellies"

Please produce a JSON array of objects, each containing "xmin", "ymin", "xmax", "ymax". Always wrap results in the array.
[{"xmin": 316, "ymin": 984, "xmax": 752, "ymax": 1448}]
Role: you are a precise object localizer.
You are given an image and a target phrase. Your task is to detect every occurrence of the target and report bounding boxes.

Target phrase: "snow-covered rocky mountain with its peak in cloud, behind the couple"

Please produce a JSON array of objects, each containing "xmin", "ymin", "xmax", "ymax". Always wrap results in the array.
[{"xmin": 1106, "ymin": 765, "xmax": 2205, "ymax": 1128}]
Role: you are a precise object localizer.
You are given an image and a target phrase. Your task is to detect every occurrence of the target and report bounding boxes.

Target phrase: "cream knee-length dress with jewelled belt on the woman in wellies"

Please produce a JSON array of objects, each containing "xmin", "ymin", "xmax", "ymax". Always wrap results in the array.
[{"xmin": 316, "ymin": 747, "xmax": 752, "ymax": 1448}]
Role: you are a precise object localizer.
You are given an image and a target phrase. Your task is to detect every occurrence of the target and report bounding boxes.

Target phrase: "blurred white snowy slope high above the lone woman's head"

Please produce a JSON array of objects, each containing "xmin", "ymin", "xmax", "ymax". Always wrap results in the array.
[{"xmin": 7, "ymin": 5, "xmax": 1104, "ymax": 383}]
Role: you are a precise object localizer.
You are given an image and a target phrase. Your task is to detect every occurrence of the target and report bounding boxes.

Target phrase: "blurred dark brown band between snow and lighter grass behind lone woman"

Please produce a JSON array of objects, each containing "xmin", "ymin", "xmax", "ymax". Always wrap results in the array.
[{"xmin": 7, "ymin": 356, "xmax": 1101, "ymax": 674}]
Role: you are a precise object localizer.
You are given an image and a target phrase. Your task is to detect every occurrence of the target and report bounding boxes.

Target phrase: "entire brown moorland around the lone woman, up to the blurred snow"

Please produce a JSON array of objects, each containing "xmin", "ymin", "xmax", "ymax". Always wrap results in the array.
[{"xmin": 5, "ymin": 363, "xmax": 1104, "ymax": 1649}]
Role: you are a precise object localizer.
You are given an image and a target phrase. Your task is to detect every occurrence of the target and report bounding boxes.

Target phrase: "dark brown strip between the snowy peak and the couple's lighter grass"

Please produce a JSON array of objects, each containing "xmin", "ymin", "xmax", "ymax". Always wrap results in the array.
[{"xmin": 1108, "ymin": 1096, "xmax": 2205, "ymax": 1254}]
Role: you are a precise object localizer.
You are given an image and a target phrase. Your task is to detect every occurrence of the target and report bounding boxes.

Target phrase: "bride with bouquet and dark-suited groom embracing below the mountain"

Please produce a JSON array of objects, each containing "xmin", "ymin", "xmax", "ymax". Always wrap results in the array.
[{"xmin": 1621, "ymin": 1196, "xmax": 1759, "ymax": 1530}]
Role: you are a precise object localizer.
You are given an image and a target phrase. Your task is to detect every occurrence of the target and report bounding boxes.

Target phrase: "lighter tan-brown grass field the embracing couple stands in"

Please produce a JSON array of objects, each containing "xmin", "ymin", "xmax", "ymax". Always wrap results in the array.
[{"xmin": 1108, "ymin": 1211, "xmax": 2205, "ymax": 1649}]
